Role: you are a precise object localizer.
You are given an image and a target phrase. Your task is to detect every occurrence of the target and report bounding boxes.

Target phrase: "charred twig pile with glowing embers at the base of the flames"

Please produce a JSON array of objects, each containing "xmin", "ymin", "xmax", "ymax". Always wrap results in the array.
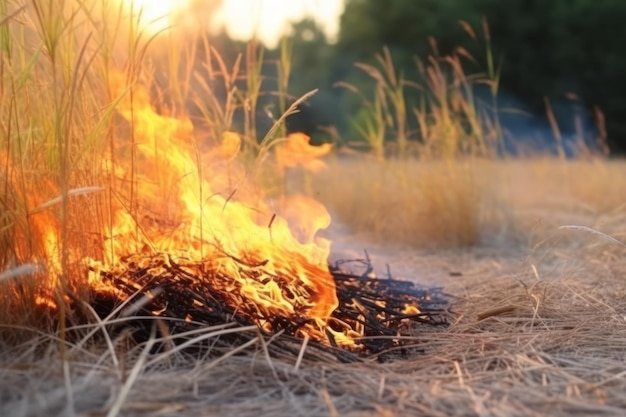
[{"xmin": 91, "ymin": 253, "xmax": 445, "ymax": 353}]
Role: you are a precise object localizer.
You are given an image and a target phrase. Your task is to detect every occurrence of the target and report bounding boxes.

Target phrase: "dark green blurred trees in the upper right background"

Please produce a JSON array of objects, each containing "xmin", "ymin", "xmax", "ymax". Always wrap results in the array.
[{"xmin": 336, "ymin": 0, "xmax": 626, "ymax": 152}]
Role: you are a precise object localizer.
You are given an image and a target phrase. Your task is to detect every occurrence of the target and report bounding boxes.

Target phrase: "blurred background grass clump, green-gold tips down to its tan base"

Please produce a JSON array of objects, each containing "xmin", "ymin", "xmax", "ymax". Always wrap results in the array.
[{"xmin": 316, "ymin": 22, "xmax": 502, "ymax": 246}]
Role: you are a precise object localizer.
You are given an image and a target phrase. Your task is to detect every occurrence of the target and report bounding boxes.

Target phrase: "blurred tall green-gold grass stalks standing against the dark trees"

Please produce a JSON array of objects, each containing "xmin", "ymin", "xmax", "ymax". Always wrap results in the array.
[{"xmin": 337, "ymin": 18, "xmax": 502, "ymax": 158}]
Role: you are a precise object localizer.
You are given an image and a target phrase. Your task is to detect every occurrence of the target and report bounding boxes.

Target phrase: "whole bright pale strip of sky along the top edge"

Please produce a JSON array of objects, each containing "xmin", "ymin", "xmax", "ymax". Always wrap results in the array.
[{"xmin": 124, "ymin": 0, "xmax": 344, "ymax": 47}]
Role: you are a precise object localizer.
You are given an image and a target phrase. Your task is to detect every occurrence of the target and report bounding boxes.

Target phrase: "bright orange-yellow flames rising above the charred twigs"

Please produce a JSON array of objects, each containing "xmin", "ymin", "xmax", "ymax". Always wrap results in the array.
[{"xmin": 89, "ymin": 75, "xmax": 344, "ymax": 346}]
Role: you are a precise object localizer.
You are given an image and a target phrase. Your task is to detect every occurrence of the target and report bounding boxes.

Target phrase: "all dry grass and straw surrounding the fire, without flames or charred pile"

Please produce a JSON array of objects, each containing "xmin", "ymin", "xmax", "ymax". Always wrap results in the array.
[{"xmin": 0, "ymin": 0, "xmax": 626, "ymax": 417}]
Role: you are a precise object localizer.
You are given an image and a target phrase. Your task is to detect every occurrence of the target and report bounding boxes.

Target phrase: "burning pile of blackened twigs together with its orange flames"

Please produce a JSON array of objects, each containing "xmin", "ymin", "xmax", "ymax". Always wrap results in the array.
[{"xmin": 52, "ymin": 75, "xmax": 441, "ymax": 352}]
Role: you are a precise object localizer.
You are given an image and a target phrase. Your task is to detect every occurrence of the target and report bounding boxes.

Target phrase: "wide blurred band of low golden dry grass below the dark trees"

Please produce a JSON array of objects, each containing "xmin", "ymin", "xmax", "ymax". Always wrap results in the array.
[{"xmin": 313, "ymin": 158, "xmax": 626, "ymax": 248}]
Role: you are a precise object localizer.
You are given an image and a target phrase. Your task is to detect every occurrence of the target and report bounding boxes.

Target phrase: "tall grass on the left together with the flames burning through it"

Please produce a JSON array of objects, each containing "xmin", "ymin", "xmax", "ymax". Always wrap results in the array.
[{"xmin": 0, "ymin": 2, "xmax": 448, "ymax": 354}]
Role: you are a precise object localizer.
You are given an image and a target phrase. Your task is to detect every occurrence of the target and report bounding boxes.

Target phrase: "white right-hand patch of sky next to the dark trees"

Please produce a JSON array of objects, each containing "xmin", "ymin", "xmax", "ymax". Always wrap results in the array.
[{"xmin": 217, "ymin": 0, "xmax": 344, "ymax": 46}]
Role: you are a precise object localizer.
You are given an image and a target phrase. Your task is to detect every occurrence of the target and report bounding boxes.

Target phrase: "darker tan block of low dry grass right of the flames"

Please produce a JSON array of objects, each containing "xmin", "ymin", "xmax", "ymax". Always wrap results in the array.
[{"xmin": 314, "ymin": 160, "xmax": 483, "ymax": 246}]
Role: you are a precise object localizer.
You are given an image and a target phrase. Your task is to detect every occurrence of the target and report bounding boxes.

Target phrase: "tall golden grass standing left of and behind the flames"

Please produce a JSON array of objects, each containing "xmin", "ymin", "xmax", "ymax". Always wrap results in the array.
[{"xmin": 0, "ymin": 0, "xmax": 289, "ymax": 332}]
